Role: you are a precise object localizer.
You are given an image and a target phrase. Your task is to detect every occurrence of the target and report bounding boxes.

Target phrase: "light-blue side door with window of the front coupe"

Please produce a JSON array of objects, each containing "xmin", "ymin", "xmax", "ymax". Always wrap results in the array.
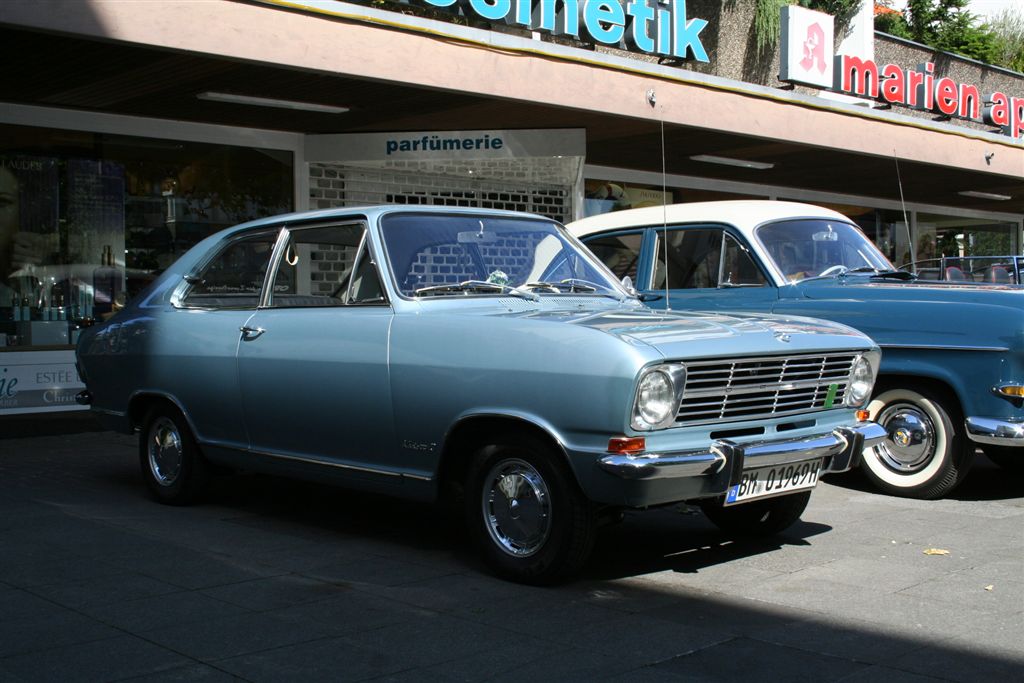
[{"xmin": 238, "ymin": 222, "xmax": 394, "ymax": 473}]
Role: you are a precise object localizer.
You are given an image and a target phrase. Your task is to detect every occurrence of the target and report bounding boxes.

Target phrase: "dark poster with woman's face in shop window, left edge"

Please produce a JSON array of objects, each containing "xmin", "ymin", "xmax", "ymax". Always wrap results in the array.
[{"xmin": 0, "ymin": 155, "xmax": 59, "ymax": 286}]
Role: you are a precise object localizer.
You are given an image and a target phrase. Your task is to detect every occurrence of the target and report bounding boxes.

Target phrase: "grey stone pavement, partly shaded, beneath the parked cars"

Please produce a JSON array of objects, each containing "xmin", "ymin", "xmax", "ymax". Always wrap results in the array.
[{"xmin": 0, "ymin": 422, "xmax": 1024, "ymax": 683}]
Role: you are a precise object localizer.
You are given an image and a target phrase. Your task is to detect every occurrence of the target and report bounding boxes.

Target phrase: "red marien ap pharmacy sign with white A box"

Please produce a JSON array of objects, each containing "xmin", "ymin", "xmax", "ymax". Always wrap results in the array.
[{"xmin": 779, "ymin": 6, "xmax": 1024, "ymax": 139}]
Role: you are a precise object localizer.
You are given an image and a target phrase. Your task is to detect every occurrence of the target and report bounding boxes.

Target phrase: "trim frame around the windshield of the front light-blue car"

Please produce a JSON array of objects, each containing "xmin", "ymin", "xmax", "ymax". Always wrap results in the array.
[{"xmin": 376, "ymin": 209, "xmax": 632, "ymax": 302}]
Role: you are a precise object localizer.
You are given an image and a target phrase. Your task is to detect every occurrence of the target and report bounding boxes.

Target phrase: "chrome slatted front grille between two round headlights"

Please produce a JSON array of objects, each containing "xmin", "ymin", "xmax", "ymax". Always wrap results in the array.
[{"xmin": 676, "ymin": 353, "xmax": 857, "ymax": 425}]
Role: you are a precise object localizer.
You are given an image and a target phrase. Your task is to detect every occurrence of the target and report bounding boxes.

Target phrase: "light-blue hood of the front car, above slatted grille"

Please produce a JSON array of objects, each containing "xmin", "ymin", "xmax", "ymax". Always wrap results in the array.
[{"xmin": 521, "ymin": 308, "xmax": 872, "ymax": 358}]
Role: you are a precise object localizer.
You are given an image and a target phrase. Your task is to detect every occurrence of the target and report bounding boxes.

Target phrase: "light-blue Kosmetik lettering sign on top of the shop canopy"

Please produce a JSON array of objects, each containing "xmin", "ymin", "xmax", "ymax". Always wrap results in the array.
[{"xmin": 348, "ymin": 0, "xmax": 709, "ymax": 61}]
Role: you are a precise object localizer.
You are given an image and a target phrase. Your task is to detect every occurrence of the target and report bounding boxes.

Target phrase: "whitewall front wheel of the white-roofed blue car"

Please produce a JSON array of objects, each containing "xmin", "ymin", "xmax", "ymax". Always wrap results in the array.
[{"xmin": 863, "ymin": 388, "xmax": 974, "ymax": 499}]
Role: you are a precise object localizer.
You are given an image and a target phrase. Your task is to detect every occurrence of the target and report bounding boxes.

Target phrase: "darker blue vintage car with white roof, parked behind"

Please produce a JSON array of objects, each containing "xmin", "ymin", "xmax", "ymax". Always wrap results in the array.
[{"xmin": 569, "ymin": 201, "xmax": 1024, "ymax": 498}]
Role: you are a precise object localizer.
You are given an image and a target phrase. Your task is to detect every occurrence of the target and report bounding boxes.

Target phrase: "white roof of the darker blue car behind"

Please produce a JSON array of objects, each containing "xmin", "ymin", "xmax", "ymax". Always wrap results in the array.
[{"xmin": 567, "ymin": 200, "xmax": 850, "ymax": 237}]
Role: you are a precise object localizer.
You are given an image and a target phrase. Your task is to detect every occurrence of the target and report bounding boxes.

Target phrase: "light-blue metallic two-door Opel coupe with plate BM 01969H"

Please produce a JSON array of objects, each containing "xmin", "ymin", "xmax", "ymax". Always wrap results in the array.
[{"xmin": 78, "ymin": 207, "xmax": 884, "ymax": 583}]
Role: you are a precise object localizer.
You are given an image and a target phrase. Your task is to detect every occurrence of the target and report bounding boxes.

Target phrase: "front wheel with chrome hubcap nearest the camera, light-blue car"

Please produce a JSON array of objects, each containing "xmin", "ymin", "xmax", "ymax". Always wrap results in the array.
[{"xmin": 465, "ymin": 438, "xmax": 596, "ymax": 585}]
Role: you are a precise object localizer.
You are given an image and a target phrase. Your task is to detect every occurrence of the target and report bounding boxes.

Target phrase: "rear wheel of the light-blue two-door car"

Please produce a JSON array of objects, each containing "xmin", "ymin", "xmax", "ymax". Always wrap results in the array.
[{"xmin": 138, "ymin": 405, "xmax": 209, "ymax": 505}]
